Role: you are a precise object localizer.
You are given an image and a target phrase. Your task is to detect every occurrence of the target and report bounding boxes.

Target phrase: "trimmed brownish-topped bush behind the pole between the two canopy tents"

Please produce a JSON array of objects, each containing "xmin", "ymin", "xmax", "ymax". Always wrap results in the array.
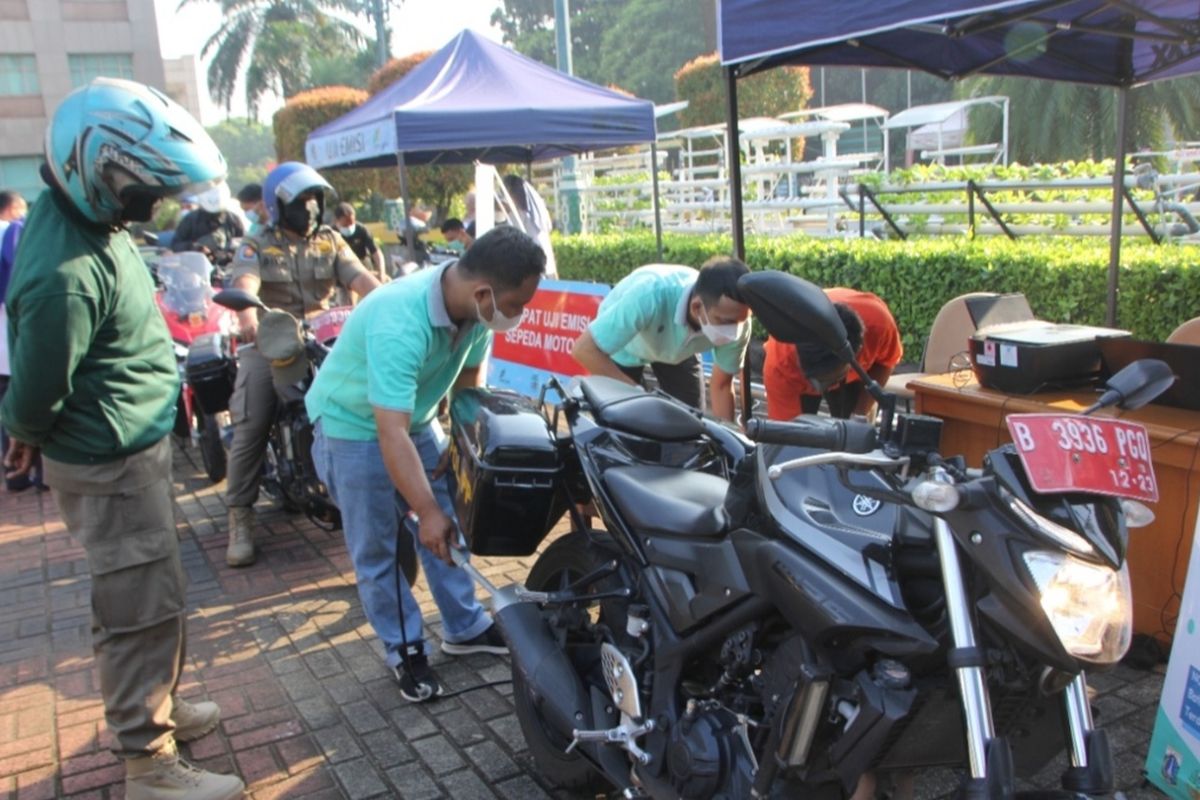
[{"xmin": 674, "ymin": 53, "xmax": 812, "ymax": 127}]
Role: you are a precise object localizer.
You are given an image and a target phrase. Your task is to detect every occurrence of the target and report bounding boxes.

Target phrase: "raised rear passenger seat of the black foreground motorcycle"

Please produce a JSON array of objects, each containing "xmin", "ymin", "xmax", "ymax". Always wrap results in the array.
[{"xmin": 580, "ymin": 375, "xmax": 704, "ymax": 441}]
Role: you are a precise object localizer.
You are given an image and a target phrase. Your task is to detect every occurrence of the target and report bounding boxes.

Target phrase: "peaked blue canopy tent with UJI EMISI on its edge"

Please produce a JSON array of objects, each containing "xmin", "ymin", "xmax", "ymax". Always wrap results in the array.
[{"xmin": 305, "ymin": 30, "xmax": 655, "ymax": 253}]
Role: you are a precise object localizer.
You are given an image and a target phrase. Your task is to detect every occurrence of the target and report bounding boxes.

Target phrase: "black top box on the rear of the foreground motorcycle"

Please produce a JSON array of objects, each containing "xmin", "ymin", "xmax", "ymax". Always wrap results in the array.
[{"xmin": 450, "ymin": 389, "xmax": 566, "ymax": 555}]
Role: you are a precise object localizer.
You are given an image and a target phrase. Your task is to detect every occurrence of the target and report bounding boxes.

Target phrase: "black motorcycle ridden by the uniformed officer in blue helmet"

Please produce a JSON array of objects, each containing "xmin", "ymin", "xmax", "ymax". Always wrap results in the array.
[{"xmin": 212, "ymin": 289, "xmax": 419, "ymax": 583}]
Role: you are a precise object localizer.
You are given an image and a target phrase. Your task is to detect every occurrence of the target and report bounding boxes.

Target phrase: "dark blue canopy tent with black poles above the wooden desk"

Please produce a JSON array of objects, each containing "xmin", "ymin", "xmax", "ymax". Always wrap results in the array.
[{"xmin": 720, "ymin": 0, "xmax": 1200, "ymax": 338}]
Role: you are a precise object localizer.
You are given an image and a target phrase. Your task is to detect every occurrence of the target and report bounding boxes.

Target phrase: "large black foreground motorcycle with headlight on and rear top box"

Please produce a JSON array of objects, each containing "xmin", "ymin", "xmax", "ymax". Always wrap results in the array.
[{"xmin": 451, "ymin": 272, "xmax": 1172, "ymax": 800}]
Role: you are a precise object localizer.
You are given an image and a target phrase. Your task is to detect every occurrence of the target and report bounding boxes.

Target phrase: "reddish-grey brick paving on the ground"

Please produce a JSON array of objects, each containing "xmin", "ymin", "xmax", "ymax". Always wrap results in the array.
[{"xmin": 0, "ymin": 441, "xmax": 1162, "ymax": 800}]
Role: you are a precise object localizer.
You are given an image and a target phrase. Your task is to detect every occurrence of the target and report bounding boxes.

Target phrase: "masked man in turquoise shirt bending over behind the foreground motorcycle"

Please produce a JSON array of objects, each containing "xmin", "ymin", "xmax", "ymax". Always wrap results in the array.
[{"xmin": 571, "ymin": 257, "xmax": 750, "ymax": 422}]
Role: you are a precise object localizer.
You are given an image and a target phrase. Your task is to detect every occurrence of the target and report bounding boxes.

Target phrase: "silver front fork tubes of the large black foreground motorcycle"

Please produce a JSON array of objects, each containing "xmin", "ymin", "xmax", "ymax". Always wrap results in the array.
[{"xmin": 934, "ymin": 501, "xmax": 1114, "ymax": 799}]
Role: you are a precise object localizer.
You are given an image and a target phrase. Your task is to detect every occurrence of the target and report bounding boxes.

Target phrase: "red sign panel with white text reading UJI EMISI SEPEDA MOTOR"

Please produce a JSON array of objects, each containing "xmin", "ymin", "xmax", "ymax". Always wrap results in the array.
[{"xmin": 492, "ymin": 288, "xmax": 604, "ymax": 375}]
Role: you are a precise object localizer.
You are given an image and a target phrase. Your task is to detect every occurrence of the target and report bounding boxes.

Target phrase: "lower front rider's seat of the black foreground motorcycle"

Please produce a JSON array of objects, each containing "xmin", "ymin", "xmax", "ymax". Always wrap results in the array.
[{"xmin": 604, "ymin": 464, "xmax": 730, "ymax": 537}]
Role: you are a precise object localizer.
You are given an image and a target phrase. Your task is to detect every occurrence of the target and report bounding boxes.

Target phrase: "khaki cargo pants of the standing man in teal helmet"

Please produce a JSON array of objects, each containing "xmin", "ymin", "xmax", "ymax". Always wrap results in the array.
[{"xmin": 46, "ymin": 437, "xmax": 187, "ymax": 758}]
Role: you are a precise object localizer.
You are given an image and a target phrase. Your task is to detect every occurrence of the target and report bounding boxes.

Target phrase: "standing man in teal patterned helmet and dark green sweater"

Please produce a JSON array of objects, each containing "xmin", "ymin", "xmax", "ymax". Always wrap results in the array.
[{"xmin": 0, "ymin": 78, "xmax": 242, "ymax": 800}]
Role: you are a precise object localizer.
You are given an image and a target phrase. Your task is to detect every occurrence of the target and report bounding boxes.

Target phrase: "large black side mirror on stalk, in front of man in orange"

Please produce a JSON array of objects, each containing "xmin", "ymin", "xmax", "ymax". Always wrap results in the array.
[{"xmin": 738, "ymin": 270, "xmax": 895, "ymax": 419}]
